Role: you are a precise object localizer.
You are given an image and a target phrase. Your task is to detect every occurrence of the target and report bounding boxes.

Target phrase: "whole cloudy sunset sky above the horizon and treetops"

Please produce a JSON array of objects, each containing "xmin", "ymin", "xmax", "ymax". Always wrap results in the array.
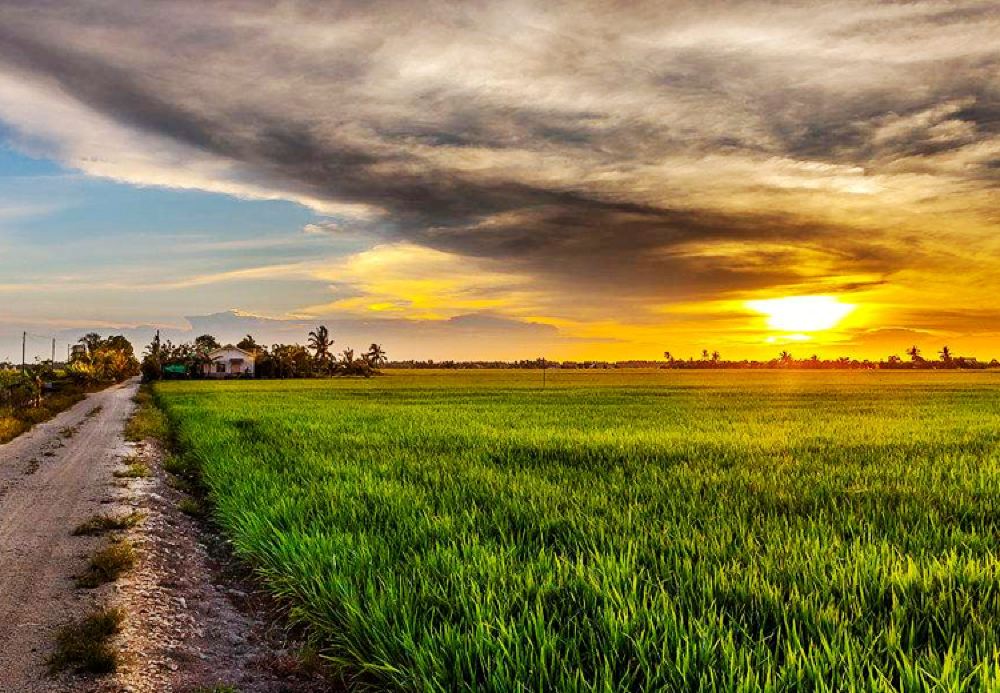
[{"xmin": 0, "ymin": 0, "xmax": 1000, "ymax": 360}]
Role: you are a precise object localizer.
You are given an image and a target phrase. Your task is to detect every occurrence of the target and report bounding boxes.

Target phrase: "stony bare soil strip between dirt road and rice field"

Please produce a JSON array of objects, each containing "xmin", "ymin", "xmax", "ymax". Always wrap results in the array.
[{"xmin": 96, "ymin": 442, "xmax": 341, "ymax": 693}]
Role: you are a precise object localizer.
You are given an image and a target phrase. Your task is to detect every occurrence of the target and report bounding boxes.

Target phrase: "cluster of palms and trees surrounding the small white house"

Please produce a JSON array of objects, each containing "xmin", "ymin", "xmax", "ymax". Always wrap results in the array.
[{"xmin": 142, "ymin": 325, "xmax": 386, "ymax": 380}]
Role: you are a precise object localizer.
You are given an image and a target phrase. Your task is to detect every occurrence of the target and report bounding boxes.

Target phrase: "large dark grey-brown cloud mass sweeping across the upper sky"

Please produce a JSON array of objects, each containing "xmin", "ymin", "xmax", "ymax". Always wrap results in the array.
[{"xmin": 0, "ymin": 0, "xmax": 1000, "ymax": 298}]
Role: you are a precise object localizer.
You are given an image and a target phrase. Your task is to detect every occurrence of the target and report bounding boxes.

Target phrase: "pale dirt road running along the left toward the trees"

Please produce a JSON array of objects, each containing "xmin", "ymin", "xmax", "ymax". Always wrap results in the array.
[{"xmin": 0, "ymin": 381, "xmax": 138, "ymax": 693}]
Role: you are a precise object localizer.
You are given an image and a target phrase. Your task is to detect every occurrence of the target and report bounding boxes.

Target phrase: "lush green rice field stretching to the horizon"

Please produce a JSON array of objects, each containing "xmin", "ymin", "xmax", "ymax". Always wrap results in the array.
[{"xmin": 156, "ymin": 370, "xmax": 1000, "ymax": 691}]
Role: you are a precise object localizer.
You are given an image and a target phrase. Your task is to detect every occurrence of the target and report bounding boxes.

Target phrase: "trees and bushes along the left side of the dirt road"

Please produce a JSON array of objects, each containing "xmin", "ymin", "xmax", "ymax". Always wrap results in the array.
[{"xmin": 0, "ymin": 333, "xmax": 139, "ymax": 443}]
